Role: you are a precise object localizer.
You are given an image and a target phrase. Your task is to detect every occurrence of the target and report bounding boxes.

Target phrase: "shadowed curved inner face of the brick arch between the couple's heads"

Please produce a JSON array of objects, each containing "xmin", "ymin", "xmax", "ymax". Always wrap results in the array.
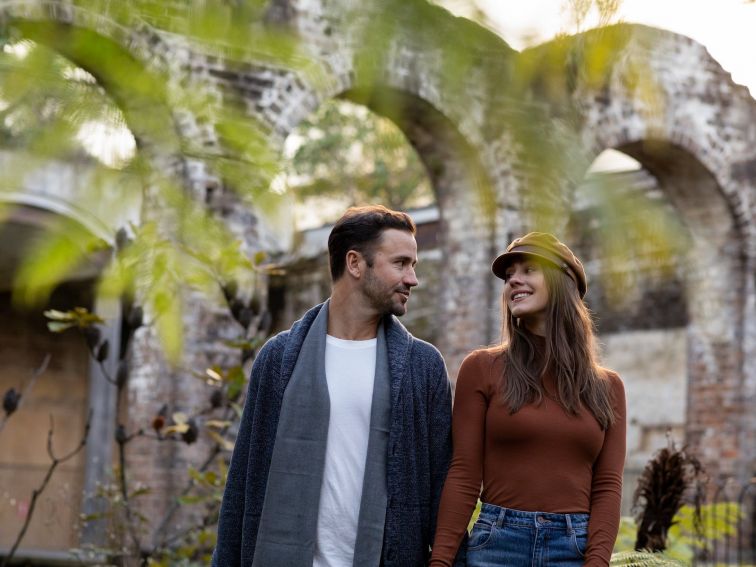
[{"xmin": 340, "ymin": 86, "xmax": 494, "ymax": 373}]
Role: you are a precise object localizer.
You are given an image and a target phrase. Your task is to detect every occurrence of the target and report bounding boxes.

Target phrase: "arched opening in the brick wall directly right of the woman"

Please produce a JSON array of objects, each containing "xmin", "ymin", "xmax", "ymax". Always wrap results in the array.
[{"xmin": 569, "ymin": 149, "xmax": 688, "ymax": 513}]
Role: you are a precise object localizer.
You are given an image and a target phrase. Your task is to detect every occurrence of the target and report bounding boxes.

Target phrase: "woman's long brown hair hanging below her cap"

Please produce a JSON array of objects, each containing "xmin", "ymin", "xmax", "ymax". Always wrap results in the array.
[{"xmin": 502, "ymin": 263, "xmax": 614, "ymax": 430}]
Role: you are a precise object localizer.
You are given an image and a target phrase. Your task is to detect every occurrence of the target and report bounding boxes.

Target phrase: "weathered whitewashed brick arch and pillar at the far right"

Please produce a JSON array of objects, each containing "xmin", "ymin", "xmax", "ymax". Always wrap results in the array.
[{"xmin": 560, "ymin": 25, "xmax": 756, "ymax": 480}]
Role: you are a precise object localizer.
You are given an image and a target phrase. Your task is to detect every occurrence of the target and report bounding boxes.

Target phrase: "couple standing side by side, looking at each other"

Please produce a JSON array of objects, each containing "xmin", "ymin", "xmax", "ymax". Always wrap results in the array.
[{"xmin": 213, "ymin": 206, "xmax": 625, "ymax": 567}]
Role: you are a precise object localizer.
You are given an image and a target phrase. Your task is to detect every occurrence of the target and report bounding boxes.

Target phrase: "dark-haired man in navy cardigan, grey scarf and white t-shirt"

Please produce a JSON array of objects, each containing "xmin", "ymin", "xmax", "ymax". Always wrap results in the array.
[{"xmin": 213, "ymin": 206, "xmax": 451, "ymax": 567}]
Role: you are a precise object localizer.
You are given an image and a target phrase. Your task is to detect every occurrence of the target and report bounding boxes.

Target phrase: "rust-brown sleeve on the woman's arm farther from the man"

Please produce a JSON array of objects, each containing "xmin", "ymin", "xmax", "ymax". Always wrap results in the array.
[{"xmin": 585, "ymin": 372, "xmax": 627, "ymax": 567}]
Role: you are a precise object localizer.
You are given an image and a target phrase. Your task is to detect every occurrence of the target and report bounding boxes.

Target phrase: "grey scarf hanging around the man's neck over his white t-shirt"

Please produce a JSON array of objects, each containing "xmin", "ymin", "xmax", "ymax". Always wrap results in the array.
[{"xmin": 252, "ymin": 302, "xmax": 391, "ymax": 567}]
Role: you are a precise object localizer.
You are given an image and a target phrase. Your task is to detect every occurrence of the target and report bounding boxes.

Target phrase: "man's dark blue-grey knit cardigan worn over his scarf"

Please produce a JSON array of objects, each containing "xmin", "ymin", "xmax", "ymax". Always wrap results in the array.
[{"xmin": 213, "ymin": 304, "xmax": 451, "ymax": 567}]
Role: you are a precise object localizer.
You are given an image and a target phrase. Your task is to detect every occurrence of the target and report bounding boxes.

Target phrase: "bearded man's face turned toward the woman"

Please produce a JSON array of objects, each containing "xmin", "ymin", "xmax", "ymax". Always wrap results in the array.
[{"xmin": 362, "ymin": 228, "xmax": 417, "ymax": 316}]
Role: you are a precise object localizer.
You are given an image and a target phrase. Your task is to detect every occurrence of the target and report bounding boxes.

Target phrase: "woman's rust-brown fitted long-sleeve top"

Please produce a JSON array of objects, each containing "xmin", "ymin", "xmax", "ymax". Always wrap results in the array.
[{"xmin": 430, "ymin": 348, "xmax": 626, "ymax": 567}]
